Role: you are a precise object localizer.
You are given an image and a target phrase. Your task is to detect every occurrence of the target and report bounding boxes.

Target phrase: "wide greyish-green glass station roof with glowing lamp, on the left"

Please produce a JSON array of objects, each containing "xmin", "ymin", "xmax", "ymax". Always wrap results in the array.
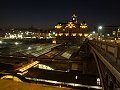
[{"xmin": 0, "ymin": 44, "xmax": 60, "ymax": 57}]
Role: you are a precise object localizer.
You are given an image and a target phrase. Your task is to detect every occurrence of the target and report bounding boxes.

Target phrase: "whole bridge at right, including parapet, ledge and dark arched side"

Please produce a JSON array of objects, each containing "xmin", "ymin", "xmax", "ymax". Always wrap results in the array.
[{"xmin": 83, "ymin": 40, "xmax": 120, "ymax": 90}]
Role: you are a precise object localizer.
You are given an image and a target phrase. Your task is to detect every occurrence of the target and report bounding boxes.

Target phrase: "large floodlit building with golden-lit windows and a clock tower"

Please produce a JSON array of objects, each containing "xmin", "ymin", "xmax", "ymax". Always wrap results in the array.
[{"xmin": 55, "ymin": 13, "xmax": 88, "ymax": 44}]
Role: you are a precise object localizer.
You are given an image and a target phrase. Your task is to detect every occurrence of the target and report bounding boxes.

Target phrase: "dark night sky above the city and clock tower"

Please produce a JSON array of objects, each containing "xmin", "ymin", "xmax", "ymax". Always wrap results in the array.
[{"xmin": 0, "ymin": 0, "xmax": 120, "ymax": 28}]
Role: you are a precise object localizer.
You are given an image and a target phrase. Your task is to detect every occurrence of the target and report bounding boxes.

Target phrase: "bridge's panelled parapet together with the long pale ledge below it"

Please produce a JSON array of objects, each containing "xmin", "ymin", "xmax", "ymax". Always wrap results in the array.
[{"xmin": 89, "ymin": 40, "xmax": 120, "ymax": 90}]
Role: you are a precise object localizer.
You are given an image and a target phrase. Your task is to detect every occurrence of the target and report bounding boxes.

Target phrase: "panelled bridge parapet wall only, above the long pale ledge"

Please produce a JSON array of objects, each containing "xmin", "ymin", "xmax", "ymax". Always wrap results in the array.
[{"xmin": 89, "ymin": 40, "xmax": 120, "ymax": 71}]
